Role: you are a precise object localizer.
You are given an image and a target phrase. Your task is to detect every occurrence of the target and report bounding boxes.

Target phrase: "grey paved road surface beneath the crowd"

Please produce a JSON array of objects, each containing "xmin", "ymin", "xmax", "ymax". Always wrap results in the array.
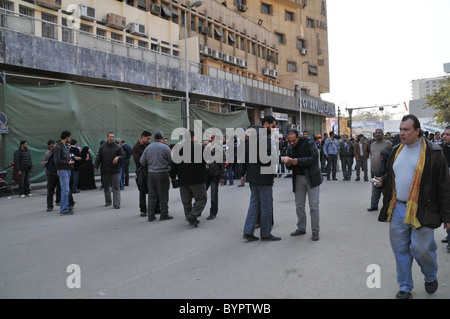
[{"xmin": 0, "ymin": 178, "xmax": 450, "ymax": 299}]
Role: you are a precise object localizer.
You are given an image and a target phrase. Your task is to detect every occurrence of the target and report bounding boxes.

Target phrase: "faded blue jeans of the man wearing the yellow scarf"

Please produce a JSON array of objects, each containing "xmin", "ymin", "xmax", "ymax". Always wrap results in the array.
[{"xmin": 389, "ymin": 202, "xmax": 438, "ymax": 292}]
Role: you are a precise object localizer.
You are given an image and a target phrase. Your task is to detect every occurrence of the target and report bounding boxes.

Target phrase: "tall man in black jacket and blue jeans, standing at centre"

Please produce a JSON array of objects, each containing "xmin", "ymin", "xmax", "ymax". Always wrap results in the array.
[{"xmin": 241, "ymin": 115, "xmax": 281, "ymax": 241}]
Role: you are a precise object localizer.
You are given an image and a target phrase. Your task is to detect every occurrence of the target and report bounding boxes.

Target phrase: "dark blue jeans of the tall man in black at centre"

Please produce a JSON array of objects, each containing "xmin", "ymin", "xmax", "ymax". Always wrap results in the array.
[{"xmin": 244, "ymin": 183, "xmax": 273, "ymax": 237}]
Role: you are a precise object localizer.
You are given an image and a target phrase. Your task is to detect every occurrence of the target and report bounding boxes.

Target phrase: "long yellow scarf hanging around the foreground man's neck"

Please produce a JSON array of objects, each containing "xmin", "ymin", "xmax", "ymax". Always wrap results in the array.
[{"xmin": 387, "ymin": 137, "xmax": 427, "ymax": 229}]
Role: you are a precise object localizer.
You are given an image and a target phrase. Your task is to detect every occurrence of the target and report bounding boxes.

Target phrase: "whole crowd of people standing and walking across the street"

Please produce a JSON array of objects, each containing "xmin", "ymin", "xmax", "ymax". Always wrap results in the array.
[{"xmin": 8, "ymin": 115, "xmax": 450, "ymax": 299}]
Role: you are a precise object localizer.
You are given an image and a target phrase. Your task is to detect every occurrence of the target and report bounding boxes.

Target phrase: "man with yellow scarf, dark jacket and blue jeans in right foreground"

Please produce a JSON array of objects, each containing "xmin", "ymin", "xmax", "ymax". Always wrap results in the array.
[{"xmin": 374, "ymin": 114, "xmax": 450, "ymax": 299}]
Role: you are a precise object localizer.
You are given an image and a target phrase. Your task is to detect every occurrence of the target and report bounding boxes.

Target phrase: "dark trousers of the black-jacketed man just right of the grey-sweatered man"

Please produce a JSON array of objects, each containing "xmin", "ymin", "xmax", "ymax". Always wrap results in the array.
[{"xmin": 180, "ymin": 183, "xmax": 208, "ymax": 218}]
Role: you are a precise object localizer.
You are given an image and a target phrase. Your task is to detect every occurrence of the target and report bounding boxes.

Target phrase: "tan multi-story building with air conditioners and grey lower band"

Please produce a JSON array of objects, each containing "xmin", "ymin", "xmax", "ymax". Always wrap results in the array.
[{"xmin": 0, "ymin": 0, "xmax": 335, "ymax": 134}]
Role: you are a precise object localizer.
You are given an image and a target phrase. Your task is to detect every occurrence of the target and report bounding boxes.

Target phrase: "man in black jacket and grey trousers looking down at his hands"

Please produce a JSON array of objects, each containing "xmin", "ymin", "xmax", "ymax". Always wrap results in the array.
[{"xmin": 282, "ymin": 130, "xmax": 323, "ymax": 241}]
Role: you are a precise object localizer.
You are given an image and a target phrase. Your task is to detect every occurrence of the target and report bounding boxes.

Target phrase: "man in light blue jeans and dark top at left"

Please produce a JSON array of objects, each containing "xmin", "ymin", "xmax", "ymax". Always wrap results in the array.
[{"xmin": 53, "ymin": 131, "xmax": 74, "ymax": 215}]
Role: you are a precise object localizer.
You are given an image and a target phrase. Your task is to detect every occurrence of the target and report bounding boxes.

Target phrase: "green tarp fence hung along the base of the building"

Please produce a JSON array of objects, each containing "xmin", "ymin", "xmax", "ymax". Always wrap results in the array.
[{"xmin": 0, "ymin": 83, "xmax": 250, "ymax": 183}]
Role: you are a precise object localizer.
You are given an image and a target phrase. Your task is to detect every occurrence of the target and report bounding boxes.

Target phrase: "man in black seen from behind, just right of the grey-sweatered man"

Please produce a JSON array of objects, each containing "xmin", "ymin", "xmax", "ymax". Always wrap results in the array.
[{"xmin": 170, "ymin": 130, "xmax": 207, "ymax": 227}]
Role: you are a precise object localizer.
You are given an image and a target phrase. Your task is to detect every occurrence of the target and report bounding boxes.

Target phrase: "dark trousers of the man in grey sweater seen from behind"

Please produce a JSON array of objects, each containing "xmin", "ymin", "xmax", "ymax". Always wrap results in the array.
[{"xmin": 147, "ymin": 172, "xmax": 170, "ymax": 217}]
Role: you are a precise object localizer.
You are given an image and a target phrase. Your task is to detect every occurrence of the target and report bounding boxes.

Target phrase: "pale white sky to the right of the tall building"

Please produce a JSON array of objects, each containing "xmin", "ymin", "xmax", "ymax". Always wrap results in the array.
[{"xmin": 322, "ymin": 0, "xmax": 450, "ymax": 116}]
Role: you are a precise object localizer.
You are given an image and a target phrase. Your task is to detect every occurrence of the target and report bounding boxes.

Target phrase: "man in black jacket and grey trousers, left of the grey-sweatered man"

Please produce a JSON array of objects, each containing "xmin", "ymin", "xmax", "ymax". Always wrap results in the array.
[{"xmin": 94, "ymin": 132, "xmax": 123, "ymax": 209}]
